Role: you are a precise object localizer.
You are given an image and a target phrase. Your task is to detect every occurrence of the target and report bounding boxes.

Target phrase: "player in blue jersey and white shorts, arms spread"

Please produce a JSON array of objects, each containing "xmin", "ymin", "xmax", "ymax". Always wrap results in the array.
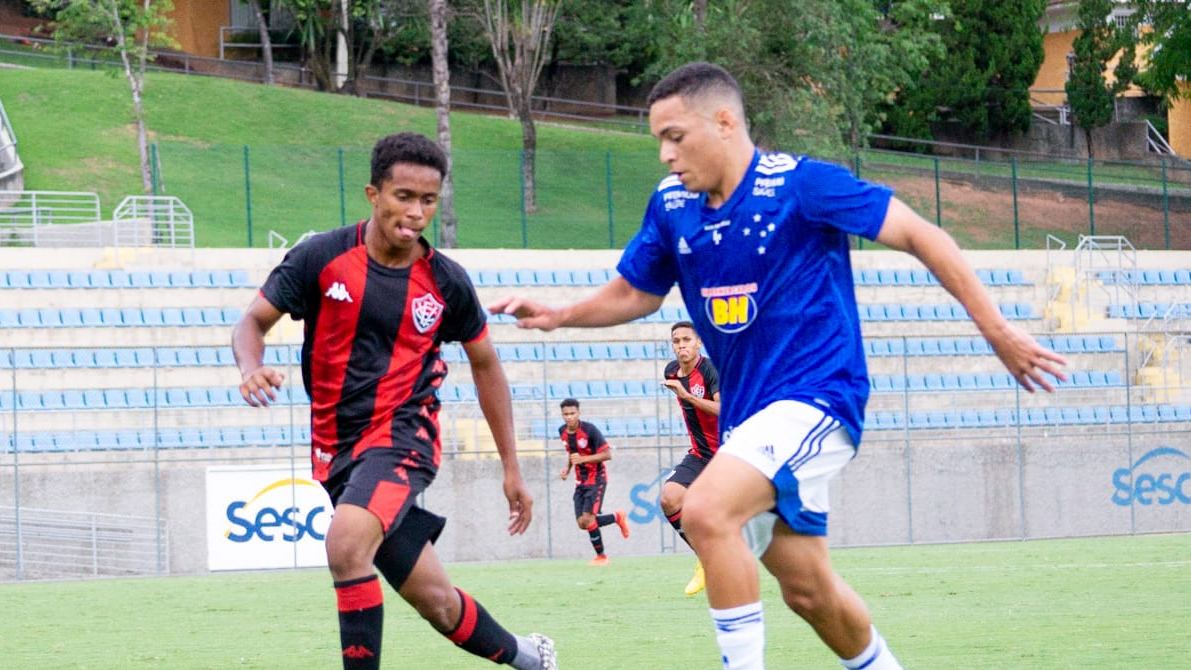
[{"xmin": 490, "ymin": 63, "xmax": 1066, "ymax": 670}]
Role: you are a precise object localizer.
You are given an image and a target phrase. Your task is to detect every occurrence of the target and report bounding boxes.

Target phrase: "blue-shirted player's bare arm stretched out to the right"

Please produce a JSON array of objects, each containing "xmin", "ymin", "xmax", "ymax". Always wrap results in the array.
[{"xmin": 877, "ymin": 198, "xmax": 1067, "ymax": 393}]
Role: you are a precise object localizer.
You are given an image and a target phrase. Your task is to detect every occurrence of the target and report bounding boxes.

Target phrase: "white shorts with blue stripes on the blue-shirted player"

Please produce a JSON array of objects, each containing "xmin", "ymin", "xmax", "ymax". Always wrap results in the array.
[{"xmin": 719, "ymin": 400, "xmax": 856, "ymax": 536}]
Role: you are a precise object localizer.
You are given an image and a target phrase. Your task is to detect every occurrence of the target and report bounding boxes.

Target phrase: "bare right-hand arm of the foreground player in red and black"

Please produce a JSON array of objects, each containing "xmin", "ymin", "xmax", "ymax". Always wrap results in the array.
[{"xmin": 463, "ymin": 336, "xmax": 534, "ymax": 536}]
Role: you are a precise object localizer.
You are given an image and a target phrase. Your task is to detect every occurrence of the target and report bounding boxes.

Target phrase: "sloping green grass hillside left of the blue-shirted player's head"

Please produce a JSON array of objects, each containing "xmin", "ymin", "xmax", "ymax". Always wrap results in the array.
[{"xmin": 0, "ymin": 69, "xmax": 663, "ymax": 248}]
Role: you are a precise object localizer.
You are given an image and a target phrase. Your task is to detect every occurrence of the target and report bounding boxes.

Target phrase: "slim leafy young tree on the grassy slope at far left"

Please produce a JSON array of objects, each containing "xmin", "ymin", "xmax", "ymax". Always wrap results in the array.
[{"xmin": 32, "ymin": 0, "xmax": 176, "ymax": 193}]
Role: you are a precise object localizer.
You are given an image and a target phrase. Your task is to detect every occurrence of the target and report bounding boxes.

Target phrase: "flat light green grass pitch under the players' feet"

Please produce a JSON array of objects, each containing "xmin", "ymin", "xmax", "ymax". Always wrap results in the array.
[{"xmin": 0, "ymin": 534, "xmax": 1191, "ymax": 670}]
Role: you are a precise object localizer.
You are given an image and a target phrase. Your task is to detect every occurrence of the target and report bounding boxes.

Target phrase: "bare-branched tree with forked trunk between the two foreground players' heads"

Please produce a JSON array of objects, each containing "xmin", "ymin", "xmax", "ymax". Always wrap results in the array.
[{"xmin": 481, "ymin": 0, "xmax": 562, "ymax": 214}]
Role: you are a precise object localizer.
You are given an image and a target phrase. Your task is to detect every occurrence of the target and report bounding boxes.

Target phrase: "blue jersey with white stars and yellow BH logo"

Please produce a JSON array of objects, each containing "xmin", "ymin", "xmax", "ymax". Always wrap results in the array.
[{"xmin": 617, "ymin": 152, "xmax": 892, "ymax": 445}]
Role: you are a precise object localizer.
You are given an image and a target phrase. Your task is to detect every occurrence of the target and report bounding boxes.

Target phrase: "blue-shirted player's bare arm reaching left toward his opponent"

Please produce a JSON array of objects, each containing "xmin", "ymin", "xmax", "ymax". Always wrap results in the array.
[{"xmin": 488, "ymin": 277, "xmax": 666, "ymax": 331}]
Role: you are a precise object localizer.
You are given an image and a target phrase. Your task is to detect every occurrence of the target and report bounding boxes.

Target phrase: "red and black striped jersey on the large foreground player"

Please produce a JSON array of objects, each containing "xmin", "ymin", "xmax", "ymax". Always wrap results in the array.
[{"xmin": 261, "ymin": 221, "xmax": 487, "ymax": 481}]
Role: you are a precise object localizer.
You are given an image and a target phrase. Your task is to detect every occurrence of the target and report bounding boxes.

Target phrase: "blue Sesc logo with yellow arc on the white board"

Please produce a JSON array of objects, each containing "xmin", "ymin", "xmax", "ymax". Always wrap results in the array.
[{"xmin": 224, "ymin": 478, "xmax": 331, "ymax": 543}]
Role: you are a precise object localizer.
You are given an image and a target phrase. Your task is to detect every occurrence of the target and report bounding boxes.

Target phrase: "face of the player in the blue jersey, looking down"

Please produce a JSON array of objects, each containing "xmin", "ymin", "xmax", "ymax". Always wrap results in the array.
[{"xmin": 649, "ymin": 95, "xmax": 724, "ymax": 193}]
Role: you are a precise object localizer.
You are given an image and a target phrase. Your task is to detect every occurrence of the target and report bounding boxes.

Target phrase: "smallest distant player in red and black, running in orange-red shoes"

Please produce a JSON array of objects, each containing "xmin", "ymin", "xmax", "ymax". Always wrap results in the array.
[{"xmin": 559, "ymin": 397, "xmax": 629, "ymax": 565}]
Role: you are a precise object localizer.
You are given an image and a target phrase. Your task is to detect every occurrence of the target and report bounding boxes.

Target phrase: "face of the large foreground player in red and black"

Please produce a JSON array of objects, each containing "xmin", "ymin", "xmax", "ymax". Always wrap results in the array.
[{"xmin": 364, "ymin": 163, "xmax": 442, "ymax": 255}]
